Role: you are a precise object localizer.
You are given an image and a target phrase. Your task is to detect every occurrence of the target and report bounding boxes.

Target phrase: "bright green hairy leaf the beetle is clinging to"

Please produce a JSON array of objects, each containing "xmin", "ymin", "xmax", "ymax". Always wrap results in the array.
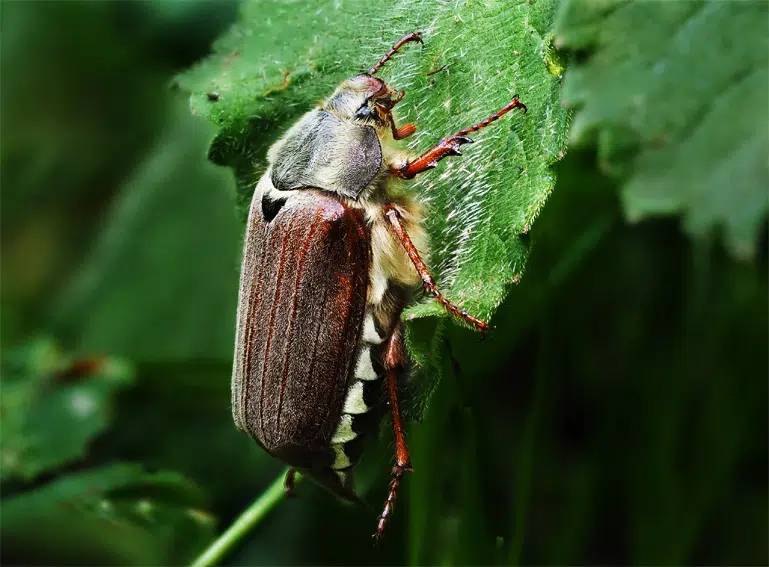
[{"xmin": 177, "ymin": 0, "xmax": 569, "ymax": 415}]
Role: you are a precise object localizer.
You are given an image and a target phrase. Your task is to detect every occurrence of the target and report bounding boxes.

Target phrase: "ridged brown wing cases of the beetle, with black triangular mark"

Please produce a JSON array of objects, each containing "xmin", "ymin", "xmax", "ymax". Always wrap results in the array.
[{"xmin": 233, "ymin": 186, "xmax": 370, "ymax": 469}]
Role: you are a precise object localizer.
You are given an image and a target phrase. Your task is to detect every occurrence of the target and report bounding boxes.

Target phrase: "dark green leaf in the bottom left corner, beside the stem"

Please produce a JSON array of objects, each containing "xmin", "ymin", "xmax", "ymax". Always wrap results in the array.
[{"xmin": 2, "ymin": 464, "xmax": 215, "ymax": 565}]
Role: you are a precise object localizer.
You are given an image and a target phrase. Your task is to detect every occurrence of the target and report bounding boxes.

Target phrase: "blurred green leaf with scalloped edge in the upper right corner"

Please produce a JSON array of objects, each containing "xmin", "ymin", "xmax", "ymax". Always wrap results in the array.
[{"xmin": 556, "ymin": 0, "xmax": 769, "ymax": 258}]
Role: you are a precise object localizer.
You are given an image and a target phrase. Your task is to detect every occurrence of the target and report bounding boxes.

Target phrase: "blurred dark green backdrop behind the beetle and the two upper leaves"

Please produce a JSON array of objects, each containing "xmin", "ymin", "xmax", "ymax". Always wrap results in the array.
[{"xmin": 0, "ymin": 1, "xmax": 769, "ymax": 565}]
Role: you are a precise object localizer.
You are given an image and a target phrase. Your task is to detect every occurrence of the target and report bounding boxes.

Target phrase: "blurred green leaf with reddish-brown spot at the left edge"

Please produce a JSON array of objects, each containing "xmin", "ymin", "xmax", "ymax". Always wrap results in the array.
[{"xmin": 0, "ymin": 339, "xmax": 133, "ymax": 480}]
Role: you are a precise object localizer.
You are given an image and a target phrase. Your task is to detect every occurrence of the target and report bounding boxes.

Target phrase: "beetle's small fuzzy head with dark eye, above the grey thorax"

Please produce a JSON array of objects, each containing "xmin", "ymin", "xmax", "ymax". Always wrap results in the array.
[{"xmin": 324, "ymin": 74, "xmax": 403, "ymax": 130}]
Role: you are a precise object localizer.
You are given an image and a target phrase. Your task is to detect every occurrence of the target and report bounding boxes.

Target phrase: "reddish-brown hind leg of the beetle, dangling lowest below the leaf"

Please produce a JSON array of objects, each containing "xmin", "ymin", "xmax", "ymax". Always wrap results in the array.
[{"xmin": 374, "ymin": 325, "xmax": 412, "ymax": 541}]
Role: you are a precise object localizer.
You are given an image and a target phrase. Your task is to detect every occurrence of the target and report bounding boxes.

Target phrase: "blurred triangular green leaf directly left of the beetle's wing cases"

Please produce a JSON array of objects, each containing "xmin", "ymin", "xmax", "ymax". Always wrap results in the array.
[{"xmin": 53, "ymin": 108, "xmax": 240, "ymax": 361}]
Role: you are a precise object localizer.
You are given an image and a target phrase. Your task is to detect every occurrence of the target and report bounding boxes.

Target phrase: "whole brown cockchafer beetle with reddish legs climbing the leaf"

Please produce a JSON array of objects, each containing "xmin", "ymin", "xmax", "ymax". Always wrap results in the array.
[{"xmin": 232, "ymin": 32, "xmax": 526, "ymax": 538}]
